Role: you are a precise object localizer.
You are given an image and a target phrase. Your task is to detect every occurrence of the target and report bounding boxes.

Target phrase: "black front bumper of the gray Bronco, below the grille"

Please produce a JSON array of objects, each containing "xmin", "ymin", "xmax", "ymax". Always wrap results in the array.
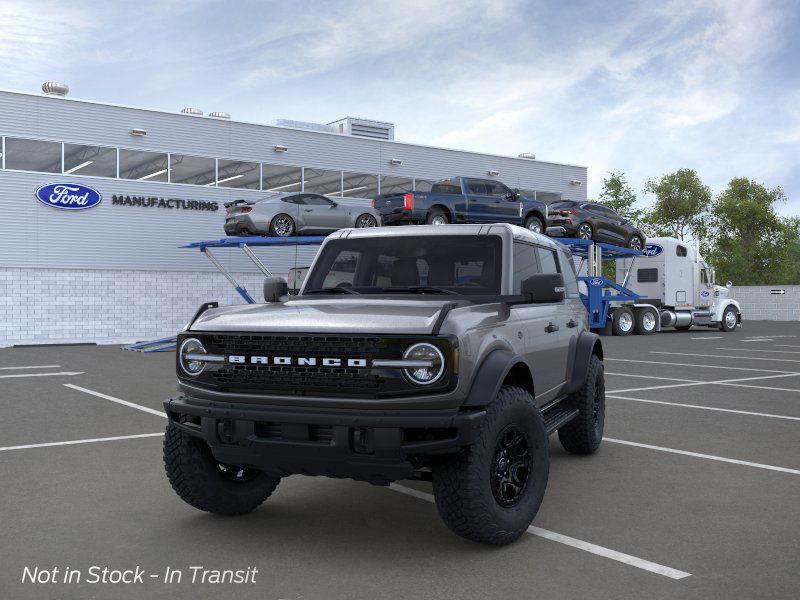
[{"xmin": 164, "ymin": 397, "xmax": 486, "ymax": 484}]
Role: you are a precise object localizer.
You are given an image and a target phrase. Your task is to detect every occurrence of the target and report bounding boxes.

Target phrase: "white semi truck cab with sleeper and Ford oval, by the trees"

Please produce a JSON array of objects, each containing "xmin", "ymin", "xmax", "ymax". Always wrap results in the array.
[{"xmin": 609, "ymin": 237, "xmax": 742, "ymax": 335}]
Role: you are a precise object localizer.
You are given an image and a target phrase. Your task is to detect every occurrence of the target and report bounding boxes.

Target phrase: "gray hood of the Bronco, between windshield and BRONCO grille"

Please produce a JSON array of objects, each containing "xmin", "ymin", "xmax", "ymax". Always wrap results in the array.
[{"xmin": 184, "ymin": 297, "xmax": 452, "ymax": 334}]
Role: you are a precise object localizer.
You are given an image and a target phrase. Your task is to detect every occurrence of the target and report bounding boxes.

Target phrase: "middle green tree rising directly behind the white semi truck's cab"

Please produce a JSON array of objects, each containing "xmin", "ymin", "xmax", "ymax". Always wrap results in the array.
[{"xmin": 642, "ymin": 169, "xmax": 711, "ymax": 240}]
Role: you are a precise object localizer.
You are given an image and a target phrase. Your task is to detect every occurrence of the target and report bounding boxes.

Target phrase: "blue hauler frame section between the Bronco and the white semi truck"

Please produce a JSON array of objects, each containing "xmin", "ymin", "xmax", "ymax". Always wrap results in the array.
[{"xmin": 555, "ymin": 238, "xmax": 642, "ymax": 329}]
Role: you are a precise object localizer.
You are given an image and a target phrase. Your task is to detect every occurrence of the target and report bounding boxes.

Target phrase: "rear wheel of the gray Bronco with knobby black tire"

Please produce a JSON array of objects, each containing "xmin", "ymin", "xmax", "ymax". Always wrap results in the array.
[{"xmin": 558, "ymin": 354, "xmax": 606, "ymax": 454}]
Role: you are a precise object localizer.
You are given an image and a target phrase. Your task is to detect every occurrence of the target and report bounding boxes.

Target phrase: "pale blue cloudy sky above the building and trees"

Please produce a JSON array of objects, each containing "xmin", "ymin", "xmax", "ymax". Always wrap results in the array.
[{"xmin": 0, "ymin": 0, "xmax": 800, "ymax": 214}]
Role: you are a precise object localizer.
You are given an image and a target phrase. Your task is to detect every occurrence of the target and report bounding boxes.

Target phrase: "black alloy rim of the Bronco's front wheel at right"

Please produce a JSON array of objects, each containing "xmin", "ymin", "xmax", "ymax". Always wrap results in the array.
[{"xmin": 491, "ymin": 423, "xmax": 531, "ymax": 508}]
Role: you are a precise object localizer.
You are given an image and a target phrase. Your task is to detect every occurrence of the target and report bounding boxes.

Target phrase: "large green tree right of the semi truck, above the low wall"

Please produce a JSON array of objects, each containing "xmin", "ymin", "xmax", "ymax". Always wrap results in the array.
[{"xmin": 707, "ymin": 177, "xmax": 800, "ymax": 285}]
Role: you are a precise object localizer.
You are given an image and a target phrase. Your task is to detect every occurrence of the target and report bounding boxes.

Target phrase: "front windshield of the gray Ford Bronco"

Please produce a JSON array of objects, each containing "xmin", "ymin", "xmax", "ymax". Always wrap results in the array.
[{"xmin": 303, "ymin": 235, "xmax": 503, "ymax": 295}]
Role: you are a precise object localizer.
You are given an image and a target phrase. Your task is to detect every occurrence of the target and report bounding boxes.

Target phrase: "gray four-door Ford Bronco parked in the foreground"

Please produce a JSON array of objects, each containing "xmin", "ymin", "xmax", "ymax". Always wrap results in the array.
[{"xmin": 164, "ymin": 224, "xmax": 605, "ymax": 544}]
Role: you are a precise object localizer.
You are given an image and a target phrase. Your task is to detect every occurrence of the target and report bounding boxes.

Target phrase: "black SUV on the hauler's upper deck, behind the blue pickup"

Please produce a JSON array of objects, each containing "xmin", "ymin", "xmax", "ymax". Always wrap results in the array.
[{"xmin": 547, "ymin": 200, "xmax": 647, "ymax": 250}]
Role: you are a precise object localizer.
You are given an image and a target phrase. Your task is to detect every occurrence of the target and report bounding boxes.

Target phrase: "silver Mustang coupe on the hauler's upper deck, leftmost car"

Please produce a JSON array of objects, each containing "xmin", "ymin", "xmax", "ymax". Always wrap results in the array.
[{"xmin": 225, "ymin": 192, "xmax": 381, "ymax": 237}]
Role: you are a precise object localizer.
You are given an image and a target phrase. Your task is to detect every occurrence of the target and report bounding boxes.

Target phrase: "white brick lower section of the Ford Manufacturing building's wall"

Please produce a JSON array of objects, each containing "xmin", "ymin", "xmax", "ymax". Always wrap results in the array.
[{"xmin": 0, "ymin": 269, "xmax": 264, "ymax": 347}]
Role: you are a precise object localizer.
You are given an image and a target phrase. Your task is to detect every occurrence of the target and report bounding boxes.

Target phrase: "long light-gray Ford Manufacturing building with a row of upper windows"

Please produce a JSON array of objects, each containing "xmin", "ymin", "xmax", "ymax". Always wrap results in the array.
[{"xmin": 0, "ymin": 85, "xmax": 586, "ymax": 346}]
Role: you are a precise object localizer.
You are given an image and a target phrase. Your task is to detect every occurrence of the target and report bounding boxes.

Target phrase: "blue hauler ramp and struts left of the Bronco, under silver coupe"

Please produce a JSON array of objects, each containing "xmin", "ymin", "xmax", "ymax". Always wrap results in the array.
[{"xmin": 123, "ymin": 236, "xmax": 325, "ymax": 353}]
